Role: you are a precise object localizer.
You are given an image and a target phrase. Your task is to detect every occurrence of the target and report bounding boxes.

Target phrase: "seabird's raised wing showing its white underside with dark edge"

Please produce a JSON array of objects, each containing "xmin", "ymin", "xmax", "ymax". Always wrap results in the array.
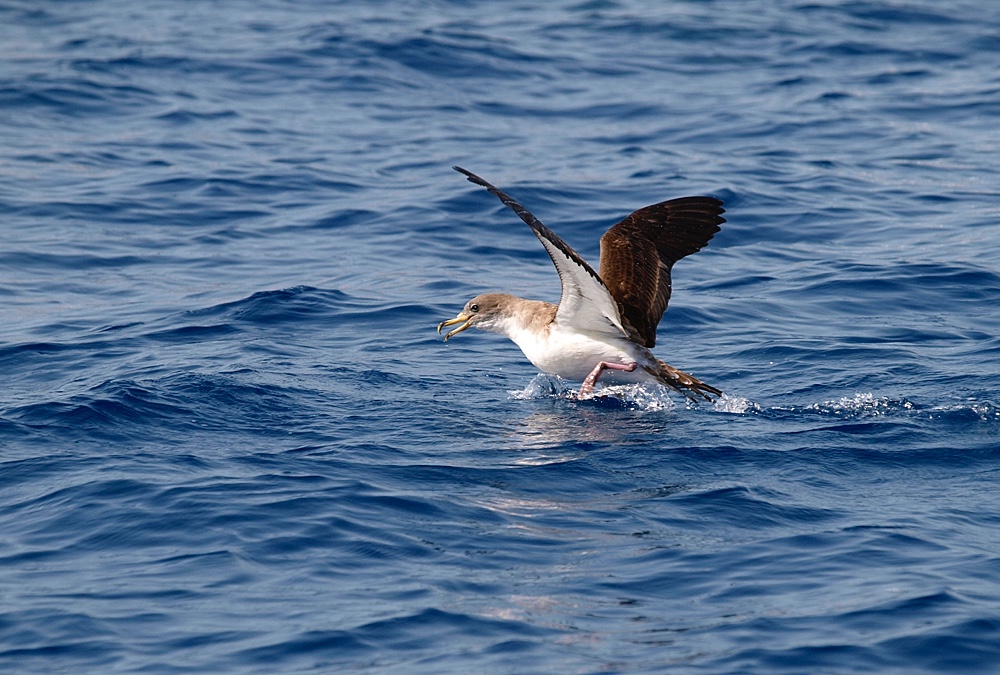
[{"xmin": 452, "ymin": 166, "xmax": 630, "ymax": 336}]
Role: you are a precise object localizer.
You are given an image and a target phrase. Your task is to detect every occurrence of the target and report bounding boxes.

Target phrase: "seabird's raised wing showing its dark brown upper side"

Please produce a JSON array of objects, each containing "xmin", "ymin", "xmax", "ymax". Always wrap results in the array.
[{"xmin": 600, "ymin": 197, "xmax": 726, "ymax": 347}]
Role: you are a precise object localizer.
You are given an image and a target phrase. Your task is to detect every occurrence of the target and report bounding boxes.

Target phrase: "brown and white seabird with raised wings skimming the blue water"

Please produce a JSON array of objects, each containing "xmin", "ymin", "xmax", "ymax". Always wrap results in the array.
[{"xmin": 438, "ymin": 166, "xmax": 726, "ymax": 401}]
